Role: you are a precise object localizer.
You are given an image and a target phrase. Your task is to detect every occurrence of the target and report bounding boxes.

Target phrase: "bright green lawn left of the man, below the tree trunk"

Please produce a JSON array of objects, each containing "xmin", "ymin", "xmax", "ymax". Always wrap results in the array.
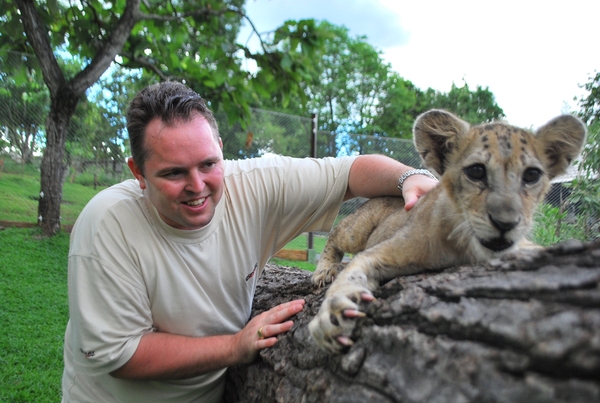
[{"xmin": 0, "ymin": 228, "xmax": 69, "ymax": 402}]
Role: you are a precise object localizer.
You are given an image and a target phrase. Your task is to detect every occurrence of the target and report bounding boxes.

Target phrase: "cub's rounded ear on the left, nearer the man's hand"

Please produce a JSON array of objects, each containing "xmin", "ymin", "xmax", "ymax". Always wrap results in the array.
[{"xmin": 413, "ymin": 109, "xmax": 470, "ymax": 176}]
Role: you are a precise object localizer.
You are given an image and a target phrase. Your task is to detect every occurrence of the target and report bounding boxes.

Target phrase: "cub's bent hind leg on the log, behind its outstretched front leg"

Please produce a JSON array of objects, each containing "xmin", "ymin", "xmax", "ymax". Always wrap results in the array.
[{"xmin": 312, "ymin": 197, "xmax": 404, "ymax": 286}]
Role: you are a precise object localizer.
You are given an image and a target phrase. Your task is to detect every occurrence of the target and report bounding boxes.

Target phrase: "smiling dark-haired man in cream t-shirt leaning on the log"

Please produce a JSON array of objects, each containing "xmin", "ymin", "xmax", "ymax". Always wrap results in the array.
[{"xmin": 62, "ymin": 82, "xmax": 435, "ymax": 402}]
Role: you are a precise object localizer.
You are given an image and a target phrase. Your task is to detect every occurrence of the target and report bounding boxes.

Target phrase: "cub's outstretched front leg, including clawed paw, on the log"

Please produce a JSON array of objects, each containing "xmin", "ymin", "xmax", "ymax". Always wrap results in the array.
[{"xmin": 309, "ymin": 233, "xmax": 422, "ymax": 352}]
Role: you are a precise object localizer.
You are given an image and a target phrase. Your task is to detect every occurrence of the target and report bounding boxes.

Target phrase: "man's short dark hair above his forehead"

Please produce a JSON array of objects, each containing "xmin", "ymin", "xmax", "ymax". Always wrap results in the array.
[{"xmin": 127, "ymin": 81, "xmax": 219, "ymax": 175}]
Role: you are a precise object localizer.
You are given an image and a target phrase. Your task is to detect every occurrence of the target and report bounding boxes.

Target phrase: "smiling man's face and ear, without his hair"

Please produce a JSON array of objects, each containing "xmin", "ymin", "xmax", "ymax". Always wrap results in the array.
[{"xmin": 128, "ymin": 115, "xmax": 223, "ymax": 230}]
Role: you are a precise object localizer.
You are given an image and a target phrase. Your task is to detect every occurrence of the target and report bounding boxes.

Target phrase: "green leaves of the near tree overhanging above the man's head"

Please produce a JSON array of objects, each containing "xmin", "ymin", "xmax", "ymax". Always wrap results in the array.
[{"xmin": 0, "ymin": 0, "xmax": 330, "ymax": 135}]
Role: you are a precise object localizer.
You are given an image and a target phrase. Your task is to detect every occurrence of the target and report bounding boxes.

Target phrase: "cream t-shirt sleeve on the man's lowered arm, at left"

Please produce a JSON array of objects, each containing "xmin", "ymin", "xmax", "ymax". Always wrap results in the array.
[{"xmin": 65, "ymin": 202, "xmax": 153, "ymax": 375}]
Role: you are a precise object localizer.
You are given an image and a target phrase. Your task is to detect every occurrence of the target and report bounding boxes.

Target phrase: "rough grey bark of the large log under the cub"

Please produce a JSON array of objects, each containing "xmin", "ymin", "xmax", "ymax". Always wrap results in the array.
[{"xmin": 225, "ymin": 242, "xmax": 600, "ymax": 403}]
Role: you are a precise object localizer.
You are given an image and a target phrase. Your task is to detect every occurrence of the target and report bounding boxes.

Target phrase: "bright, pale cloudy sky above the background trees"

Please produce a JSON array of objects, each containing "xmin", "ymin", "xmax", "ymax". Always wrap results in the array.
[{"xmin": 240, "ymin": 0, "xmax": 600, "ymax": 128}]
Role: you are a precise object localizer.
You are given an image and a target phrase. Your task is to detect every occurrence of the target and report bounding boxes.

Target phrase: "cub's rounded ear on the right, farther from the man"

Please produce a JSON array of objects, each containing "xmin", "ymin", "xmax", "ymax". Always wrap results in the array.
[{"xmin": 535, "ymin": 115, "xmax": 587, "ymax": 179}]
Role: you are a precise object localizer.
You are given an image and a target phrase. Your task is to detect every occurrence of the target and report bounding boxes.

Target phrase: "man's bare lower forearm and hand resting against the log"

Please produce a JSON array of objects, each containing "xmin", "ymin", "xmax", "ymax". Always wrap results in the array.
[{"xmin": 111, "ymin": 300, "xmax": 304, "ymax": 380}]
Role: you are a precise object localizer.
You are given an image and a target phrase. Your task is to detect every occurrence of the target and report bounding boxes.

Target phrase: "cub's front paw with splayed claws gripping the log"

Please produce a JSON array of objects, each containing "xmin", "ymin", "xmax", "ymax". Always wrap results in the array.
[{"xmin": 308, "ymin": 287, "xmax": 374, "ymax": 352}]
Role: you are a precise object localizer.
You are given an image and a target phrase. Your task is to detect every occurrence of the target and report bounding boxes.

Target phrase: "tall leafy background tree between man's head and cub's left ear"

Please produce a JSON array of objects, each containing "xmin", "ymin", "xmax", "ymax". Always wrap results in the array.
[{"xmin": 258, "ymin": 21, "xmax": 390, "ymax": 155}]
